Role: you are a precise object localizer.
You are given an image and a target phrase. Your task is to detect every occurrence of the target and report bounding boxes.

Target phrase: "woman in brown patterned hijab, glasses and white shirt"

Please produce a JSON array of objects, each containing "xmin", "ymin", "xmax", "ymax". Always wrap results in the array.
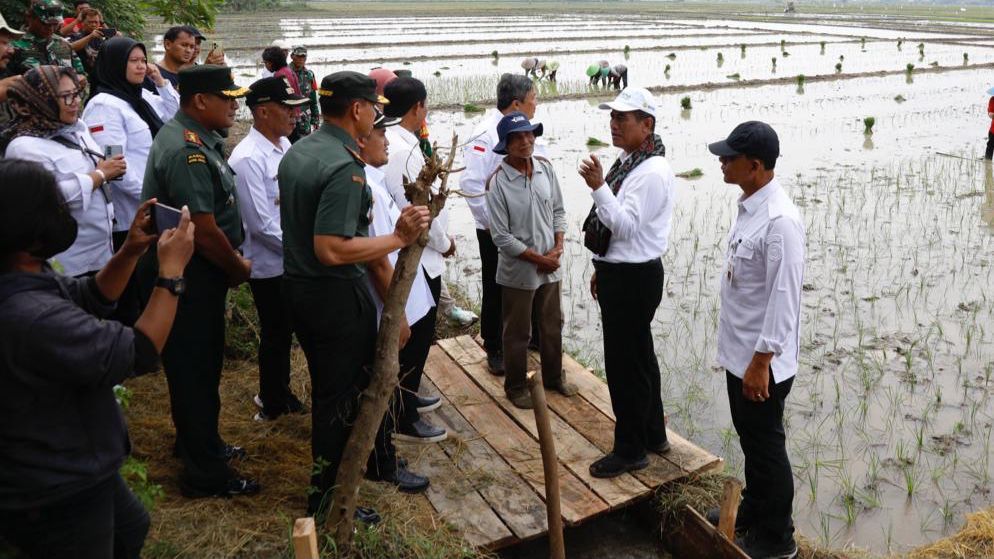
[{"xmin": 0, "ymin": 66, "xmax": 127, "ymax": 276}]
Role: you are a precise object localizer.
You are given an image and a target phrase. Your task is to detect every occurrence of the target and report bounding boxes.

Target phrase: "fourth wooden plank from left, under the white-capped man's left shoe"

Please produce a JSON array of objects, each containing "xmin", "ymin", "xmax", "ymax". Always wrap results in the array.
[{"xmin": 529, "ymin": 354, "xmax": 687, "ymax": 489}]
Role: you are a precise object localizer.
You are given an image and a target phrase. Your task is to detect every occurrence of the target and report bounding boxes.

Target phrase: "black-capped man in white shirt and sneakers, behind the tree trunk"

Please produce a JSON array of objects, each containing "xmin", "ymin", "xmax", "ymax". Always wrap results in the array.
[{"xmin": 376, "ymin": 77, "xmax": 446, "ymax": 443}]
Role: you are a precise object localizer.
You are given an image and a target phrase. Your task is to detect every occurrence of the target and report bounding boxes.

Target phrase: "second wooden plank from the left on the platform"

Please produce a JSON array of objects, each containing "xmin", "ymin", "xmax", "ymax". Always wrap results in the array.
[{"xmin": 425, "ymin": 342, "xmax": 609, "ymax": 525}]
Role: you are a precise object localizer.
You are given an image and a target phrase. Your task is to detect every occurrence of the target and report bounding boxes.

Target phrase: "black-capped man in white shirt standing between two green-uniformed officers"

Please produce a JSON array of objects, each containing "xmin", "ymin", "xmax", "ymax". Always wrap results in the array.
[{"xmin": 228, "ymin": 78, "xmax": 307, "ymax": 421}]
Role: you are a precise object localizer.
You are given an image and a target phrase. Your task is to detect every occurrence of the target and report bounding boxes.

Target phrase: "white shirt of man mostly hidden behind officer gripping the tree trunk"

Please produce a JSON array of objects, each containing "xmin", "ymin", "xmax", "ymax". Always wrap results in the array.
[{"xmin": 365, "ymin": 165, "xmax": 435, "ymax": 328}]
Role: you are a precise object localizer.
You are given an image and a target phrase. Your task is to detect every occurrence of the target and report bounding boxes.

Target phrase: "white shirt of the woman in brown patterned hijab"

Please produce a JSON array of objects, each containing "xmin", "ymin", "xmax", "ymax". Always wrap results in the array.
[{"xmin": 4, "ymin": 120, "xmax": 114, "ymax": 276}]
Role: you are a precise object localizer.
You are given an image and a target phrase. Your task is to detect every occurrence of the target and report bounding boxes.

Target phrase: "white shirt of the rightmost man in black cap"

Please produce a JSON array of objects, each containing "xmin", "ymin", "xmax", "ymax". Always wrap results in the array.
[{"xmin": 718, "ymin": 178, "xmax": 804, "ymax": 383}]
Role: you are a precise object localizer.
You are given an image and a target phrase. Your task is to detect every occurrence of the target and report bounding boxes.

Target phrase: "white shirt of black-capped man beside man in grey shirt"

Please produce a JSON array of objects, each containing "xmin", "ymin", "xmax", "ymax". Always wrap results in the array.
[{"xmin": 380, "ymin": 125, "xmax": 452, "ymax": 279}]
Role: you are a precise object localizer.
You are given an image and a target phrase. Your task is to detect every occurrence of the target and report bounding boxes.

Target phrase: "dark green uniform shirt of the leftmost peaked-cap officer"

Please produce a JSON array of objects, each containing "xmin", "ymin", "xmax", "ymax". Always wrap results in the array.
[{"xmin": 142, "ymin": 110, "xmax": 242, "ymax": 248}]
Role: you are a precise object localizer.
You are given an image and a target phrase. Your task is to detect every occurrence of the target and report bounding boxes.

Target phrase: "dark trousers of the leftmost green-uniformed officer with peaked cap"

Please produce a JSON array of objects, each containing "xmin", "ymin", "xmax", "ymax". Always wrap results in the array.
[{"xmin": 152, "ymin": 255, "xmax": 234, "ymax": 491}]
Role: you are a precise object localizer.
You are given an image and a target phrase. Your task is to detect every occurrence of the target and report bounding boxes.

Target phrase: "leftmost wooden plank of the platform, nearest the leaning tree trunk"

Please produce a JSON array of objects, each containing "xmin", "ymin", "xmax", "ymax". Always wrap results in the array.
[{"xmin": 422, "ymin": 346, "xmax": 548, "ymax": 549}]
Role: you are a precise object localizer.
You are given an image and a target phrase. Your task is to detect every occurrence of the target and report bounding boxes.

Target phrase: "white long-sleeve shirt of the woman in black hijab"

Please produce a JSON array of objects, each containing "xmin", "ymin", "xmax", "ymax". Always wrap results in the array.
[{"xmin": 83, "ymin": 80, "xmax": 179, "ymax": 231}]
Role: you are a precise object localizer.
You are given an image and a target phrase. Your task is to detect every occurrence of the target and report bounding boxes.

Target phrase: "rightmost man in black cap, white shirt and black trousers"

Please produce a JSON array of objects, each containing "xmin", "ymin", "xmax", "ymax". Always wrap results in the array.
[{"xmin": 708, "ymin": 121, "xmax": 804, "ymax": 559}]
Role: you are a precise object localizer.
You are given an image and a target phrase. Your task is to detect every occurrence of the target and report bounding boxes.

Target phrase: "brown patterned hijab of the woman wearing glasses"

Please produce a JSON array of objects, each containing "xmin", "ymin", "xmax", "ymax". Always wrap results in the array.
[{"xmin": 0, "ymin": 66, "xmax": 79, "ymax": 150}]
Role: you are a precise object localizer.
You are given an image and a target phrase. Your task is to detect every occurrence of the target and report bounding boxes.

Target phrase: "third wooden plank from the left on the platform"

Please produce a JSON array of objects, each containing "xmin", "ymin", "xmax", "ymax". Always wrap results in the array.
[{"xmin": 438, "ymin": 336, "xmax": 650, "ymax": 508}]
